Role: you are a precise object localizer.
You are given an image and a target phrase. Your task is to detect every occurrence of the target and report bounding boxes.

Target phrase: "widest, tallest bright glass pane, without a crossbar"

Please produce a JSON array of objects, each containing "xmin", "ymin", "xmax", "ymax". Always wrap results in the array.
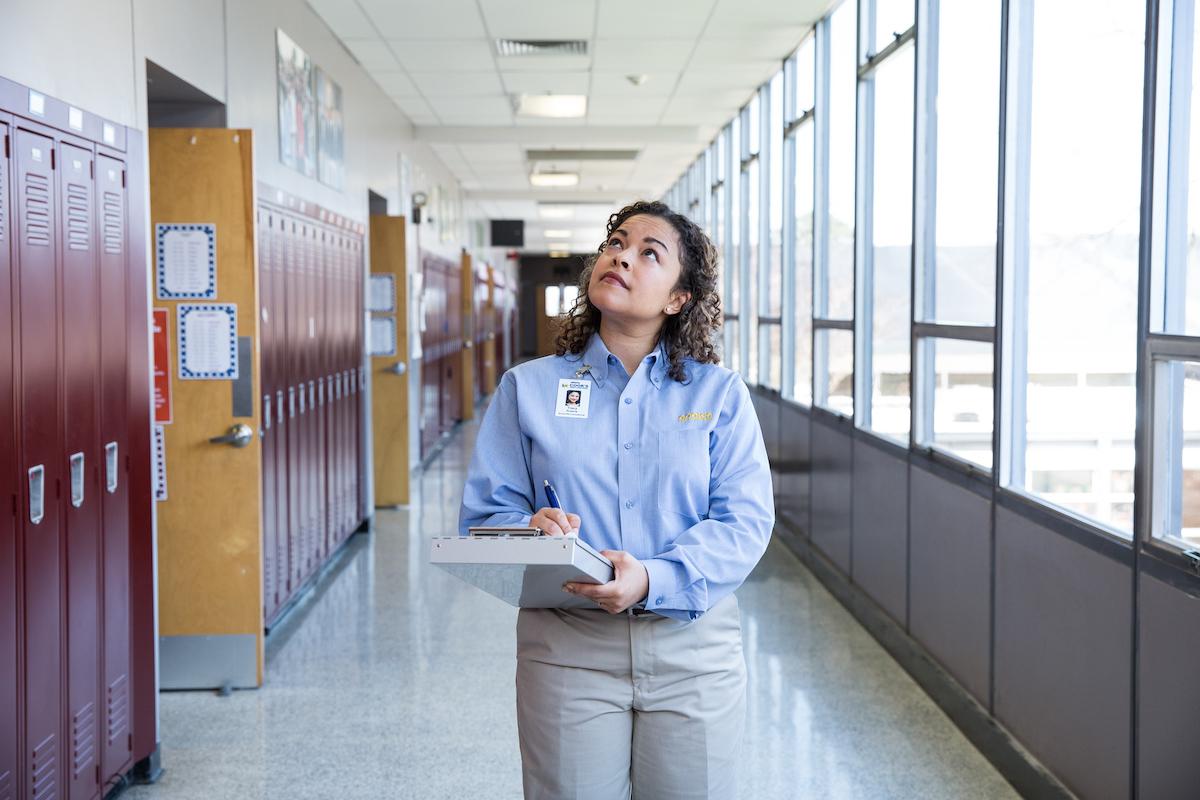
[{"xmin": 1010, "ymin": 0, "xmax": 1145, "ymax": 533}]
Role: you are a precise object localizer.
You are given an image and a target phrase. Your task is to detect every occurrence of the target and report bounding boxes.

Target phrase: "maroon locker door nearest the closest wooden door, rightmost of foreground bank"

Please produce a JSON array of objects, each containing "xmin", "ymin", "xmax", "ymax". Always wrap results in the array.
[{"xmin": 96, "ymin": 156, "xmax": 132, "ymax": 782}]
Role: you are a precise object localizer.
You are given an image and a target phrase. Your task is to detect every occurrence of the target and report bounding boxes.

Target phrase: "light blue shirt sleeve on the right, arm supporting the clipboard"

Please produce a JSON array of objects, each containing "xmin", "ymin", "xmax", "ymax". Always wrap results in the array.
[{"xmin": 643, "ymin": 378, "xmax": 775, "ymax": 619}]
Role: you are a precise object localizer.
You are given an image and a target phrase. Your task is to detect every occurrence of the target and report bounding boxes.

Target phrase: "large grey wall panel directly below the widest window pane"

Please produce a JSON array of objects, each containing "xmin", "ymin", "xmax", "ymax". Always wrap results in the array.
[{"xmin": 994, "ymin": 507, "xmax": 1133, "ymax": 799}]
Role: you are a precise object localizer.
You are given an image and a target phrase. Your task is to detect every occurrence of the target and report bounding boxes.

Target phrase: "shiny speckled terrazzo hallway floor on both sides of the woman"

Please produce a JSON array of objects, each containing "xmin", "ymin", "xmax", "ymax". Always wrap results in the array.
[{"xmin": 120, "ymin": 417, "xmax": 1016, "ymax": 800}]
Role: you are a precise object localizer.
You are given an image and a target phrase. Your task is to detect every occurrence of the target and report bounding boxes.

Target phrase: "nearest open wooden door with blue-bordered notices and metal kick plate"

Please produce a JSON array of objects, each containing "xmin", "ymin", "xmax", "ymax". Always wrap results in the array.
[{"xmin": 150, "ymin": 128, "xmax": 262, "ymax": 688}]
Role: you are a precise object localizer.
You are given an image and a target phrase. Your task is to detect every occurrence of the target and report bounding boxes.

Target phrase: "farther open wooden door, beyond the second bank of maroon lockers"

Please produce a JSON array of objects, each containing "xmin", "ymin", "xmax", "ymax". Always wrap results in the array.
[{"xmin": 371, "ymin": 215, "xmax": 409, "ymax": 506}]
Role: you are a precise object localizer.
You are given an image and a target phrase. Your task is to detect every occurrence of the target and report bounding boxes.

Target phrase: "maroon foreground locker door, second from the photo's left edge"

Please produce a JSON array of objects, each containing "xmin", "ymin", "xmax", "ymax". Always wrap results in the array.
[{"xmin": 13, "ymin": 131, "xmax": 64, "ymax": 798}]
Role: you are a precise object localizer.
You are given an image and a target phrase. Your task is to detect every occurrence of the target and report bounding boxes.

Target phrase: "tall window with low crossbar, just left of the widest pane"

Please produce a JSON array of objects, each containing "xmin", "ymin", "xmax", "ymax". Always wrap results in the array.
[{"xmin": 913, "ymin": 0, "xmax": 1001, "ymax": 469}]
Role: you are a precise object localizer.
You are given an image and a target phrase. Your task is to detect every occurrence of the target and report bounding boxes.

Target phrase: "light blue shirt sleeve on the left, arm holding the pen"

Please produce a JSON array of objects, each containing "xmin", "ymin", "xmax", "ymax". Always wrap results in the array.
[{"xmin": 458, "ymin": 373, "xmax": 534, "ymax": 536}]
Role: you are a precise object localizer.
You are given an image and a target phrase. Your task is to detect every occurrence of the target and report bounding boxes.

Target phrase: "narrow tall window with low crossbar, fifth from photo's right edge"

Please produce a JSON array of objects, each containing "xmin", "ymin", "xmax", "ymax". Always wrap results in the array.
[{"xmin": 812, "ymin": 0, "xmax": 858, "ymax": 415}]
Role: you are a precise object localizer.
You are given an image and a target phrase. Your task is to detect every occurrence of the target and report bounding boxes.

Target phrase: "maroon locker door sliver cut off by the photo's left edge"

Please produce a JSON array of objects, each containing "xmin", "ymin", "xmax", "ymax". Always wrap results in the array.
[{"xmin": 0, "ymin": 115, "xmax": 22, "ymax": 798}]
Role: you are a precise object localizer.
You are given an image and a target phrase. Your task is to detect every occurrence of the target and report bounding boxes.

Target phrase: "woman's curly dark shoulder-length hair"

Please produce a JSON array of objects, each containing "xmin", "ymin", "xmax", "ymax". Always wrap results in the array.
[{"xmin": 554, "ymin": 200, "xmax": 721, "ymax": 383}]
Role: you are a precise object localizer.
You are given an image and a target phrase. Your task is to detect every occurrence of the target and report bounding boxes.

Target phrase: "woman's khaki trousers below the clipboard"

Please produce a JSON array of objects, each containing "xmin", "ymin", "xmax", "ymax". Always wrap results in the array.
[{"xmin": 517, "ymin": 596, "xmax": 746, "ymax": 800}]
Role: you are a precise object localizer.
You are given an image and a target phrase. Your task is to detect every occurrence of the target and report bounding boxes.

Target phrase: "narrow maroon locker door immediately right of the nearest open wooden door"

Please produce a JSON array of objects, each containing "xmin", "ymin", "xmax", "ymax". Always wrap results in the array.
[{"xmin": 257, "ymin": 207, "xmax": 277, "ymax": 622}]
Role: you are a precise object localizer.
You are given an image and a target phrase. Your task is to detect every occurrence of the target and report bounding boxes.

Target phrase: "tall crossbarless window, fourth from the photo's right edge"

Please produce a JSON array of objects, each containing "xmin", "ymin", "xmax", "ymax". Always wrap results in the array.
[{"xmin": 854, "ymin": 0, "xmax": 916, "ymax": 445}]
